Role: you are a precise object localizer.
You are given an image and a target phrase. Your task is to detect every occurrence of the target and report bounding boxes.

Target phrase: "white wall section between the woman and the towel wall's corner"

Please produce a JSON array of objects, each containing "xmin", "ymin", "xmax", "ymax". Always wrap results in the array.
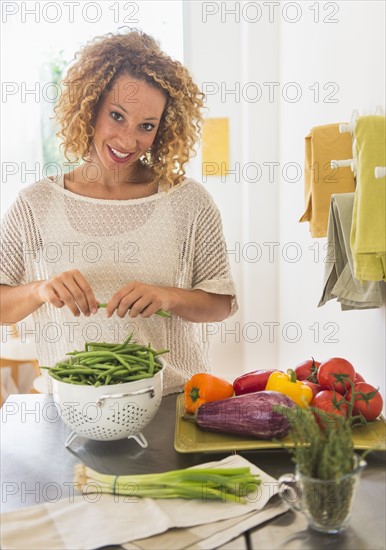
[{"xmin": 184, "ymin": 2, "xmax": 279, "ymax": 379}]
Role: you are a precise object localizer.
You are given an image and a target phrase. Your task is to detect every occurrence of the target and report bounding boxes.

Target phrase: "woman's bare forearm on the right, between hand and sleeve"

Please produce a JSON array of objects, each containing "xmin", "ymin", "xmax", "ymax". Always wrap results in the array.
[{"xmin": 170, "ymin": 288, "xmax": 232, "ymax": 323}]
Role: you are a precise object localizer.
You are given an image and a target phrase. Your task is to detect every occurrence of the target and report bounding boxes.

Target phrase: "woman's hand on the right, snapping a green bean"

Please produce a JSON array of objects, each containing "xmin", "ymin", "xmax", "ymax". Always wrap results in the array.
[{"xmin": 102, "ymin": 281, "xmax": 176, "ymax": 319}]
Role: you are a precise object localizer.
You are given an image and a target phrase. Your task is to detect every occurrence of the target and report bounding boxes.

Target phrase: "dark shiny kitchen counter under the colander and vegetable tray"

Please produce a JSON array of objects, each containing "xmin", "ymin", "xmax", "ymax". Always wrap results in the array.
[{"xmin": 1, "ymin": 394, "xmax": 386, "ymax": 550}]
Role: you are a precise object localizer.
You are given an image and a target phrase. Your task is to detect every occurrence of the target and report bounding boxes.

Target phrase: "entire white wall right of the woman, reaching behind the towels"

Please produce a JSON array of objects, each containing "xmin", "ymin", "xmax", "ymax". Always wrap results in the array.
[{"xmin": 184, "ymin": 1, "xmax": 386, "ymax": 406}]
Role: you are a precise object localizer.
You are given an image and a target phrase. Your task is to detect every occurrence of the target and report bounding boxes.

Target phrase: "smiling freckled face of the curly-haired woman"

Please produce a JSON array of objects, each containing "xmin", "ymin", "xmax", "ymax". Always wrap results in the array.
[{"xmin": 90, "ymin": 75, "xmax": 166, "ymax": 179}]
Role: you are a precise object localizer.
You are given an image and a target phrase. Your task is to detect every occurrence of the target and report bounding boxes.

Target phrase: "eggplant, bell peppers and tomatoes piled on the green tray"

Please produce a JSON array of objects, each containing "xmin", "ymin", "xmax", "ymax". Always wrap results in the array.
[{"xmin": 184, "ymin": 357, "xmax": 383, "ymax": 439}]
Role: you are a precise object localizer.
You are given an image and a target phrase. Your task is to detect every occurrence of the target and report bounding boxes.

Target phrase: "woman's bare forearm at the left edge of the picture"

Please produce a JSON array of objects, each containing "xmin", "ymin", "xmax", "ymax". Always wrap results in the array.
[{"xmin": 0, "ymin": 281, "xmax": 43, "ymax": 325}]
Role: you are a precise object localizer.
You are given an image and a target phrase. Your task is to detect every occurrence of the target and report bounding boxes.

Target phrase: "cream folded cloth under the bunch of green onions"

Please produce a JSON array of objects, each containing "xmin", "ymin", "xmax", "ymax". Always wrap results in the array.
[{"xmin": 1, "ymin": 455, "xmax": 287, "ymax": 550}]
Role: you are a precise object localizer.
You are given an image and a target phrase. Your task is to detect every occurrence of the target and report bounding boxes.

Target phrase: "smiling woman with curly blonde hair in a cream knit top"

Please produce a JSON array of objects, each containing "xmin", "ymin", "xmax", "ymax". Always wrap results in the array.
[{"xmin": 0, "ymin": 30, "xmax": 237, "ymax": 393}]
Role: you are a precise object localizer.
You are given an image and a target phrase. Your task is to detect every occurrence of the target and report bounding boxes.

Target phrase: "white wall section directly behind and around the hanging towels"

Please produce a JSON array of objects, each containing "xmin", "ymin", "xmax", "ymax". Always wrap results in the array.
[{"xmin": 279, "ymin": 1, "xmax": 386, "ymax": 402}]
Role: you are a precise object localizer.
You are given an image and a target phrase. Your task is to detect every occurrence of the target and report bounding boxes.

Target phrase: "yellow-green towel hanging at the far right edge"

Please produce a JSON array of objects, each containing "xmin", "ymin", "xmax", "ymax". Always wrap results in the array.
[{"xmin": 350, "ymin": 115, "xmax": 386, "ymax": 281}]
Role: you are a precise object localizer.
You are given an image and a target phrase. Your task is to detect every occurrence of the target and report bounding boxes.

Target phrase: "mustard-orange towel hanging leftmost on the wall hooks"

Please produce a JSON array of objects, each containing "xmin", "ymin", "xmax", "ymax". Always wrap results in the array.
[{"xmin": 299, "ymin": 124, "xmax": 355, "ymax": 237}]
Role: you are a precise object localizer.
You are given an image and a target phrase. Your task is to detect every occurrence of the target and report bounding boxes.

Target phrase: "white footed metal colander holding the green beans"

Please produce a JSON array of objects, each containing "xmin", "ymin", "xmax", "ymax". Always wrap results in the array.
[{"xmin": 52, "ymin": 368, "xmax": 164, "ymax": 447}]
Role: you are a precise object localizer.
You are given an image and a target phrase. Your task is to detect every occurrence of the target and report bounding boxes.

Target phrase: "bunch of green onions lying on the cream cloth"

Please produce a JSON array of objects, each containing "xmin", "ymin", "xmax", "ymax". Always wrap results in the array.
[{"xmin": 75, "ymin": 464, "xmax": 261, "ymax": 503}]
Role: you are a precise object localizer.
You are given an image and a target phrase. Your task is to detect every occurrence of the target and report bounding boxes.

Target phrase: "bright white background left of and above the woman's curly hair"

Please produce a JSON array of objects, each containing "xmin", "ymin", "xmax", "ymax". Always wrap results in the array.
[{"xmin": 0, "ymin": 0, "xmax": 183, "ymax": 216}]
